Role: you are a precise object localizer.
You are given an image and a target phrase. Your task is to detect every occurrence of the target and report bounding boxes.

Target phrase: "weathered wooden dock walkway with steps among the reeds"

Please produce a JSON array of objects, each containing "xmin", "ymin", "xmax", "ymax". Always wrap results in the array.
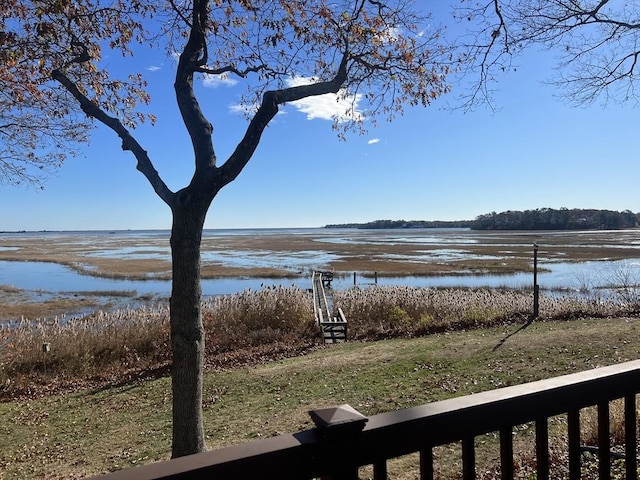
[{"xmin": 312, "ymin": 272, "xmax": 347, "ymax": 343}]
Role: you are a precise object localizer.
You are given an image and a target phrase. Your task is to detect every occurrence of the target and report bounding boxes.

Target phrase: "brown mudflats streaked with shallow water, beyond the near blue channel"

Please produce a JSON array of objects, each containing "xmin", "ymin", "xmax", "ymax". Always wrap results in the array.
[{"xmin": 0, "ymin": 229, "xmax": 640, "ymax": 283}]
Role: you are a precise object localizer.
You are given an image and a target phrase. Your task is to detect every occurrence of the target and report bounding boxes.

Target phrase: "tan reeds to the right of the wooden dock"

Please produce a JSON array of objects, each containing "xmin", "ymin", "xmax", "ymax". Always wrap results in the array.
[{"xmin": 334, "ymin": 286, "xmax": 639, "ymax": 339}]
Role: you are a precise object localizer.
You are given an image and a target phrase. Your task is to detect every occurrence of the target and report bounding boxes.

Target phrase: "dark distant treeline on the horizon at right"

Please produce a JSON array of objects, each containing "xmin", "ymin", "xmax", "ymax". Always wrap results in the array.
[{"xmin": 325, "ymin": 208, "xmax": 640, "ymax": 230}]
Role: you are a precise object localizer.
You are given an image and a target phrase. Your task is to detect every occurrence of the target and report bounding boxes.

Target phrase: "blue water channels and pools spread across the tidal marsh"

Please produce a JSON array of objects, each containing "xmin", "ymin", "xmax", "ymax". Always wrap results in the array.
[{"xmin": 0, "ymin": 229, "xmax": 640, "ymax": 296}]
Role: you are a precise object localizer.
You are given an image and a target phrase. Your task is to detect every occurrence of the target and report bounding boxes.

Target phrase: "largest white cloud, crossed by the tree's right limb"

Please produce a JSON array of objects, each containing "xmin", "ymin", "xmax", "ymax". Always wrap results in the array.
[{"xmin": 287, "ymin": 77, "xmax": 362, "ymax": 122}]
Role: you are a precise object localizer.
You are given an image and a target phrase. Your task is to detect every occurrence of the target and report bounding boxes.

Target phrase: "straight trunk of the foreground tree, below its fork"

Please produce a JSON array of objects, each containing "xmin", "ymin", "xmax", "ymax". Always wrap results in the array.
[{"xmin": 170, "ymin": 204, "xmax": 207, "ymax": 458}]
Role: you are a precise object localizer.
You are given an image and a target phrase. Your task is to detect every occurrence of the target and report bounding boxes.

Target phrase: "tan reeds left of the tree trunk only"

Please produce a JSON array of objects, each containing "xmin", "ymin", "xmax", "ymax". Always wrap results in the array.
[{"xmin": 0, "ymin": 306, "xmax": 168, "ymax": 393}]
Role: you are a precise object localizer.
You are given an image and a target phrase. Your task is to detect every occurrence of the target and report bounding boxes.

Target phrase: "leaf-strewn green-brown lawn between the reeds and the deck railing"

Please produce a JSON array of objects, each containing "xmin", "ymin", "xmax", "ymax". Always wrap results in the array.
[{"xmin": 0, "ymin": 319, "xmax": 640, "ymax": 480}]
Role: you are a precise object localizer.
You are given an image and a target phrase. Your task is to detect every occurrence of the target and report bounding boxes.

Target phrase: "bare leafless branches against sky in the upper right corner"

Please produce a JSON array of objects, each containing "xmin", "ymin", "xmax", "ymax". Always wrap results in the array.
[{"xmin": 457, "ymin": 0, "xmax": 640, "ymax": 105}]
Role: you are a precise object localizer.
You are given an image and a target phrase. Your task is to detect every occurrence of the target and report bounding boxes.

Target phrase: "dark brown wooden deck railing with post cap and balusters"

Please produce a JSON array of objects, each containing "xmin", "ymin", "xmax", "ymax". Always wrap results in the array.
[{"xmin": 91, "ymin": 360, "xmax": 640, "ymax": 480}]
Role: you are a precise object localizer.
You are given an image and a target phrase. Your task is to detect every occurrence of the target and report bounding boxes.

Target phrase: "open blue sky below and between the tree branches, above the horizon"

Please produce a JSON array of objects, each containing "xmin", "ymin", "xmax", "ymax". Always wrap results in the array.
[{"xmin": 0, "ymin": 8, "xmax": 640, "ymax": 231}]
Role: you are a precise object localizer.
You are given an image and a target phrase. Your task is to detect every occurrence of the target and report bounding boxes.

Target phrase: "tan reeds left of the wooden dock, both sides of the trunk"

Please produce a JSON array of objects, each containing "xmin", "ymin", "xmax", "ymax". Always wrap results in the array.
[{"xmin": 0, "ymin": 287, "xmax": 314, "ymax": 398}]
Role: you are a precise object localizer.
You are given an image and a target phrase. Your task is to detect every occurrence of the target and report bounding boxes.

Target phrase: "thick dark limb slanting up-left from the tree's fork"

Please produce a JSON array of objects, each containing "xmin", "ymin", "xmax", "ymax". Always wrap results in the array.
[{"xmin": 51, "ymin": 69, "xmax": 174, "ymax": 206}]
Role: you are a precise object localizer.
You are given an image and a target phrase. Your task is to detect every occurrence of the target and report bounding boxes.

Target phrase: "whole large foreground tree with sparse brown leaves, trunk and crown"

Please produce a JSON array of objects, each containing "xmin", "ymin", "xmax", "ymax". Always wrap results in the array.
[{"xmin": 0, "ymin": 0, "xmax": 458, "ymax": 457}]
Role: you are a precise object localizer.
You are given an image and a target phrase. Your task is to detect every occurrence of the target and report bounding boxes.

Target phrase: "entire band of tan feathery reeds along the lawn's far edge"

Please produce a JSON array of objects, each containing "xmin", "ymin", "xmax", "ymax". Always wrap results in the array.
[{"xmin": 0, "ymin": 287, "xmax": 638, "ymax": 398}]
